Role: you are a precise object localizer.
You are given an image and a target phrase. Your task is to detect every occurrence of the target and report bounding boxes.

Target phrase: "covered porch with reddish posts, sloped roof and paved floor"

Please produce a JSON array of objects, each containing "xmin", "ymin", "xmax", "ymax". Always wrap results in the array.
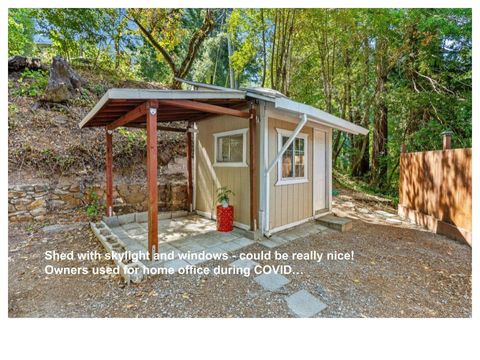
[{"xmin": 79, "ymin": 89, "xmax": 258, "ymax": 259}]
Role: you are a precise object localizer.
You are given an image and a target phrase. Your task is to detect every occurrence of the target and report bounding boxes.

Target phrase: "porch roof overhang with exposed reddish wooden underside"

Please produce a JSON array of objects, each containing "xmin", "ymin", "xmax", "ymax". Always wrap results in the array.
[{"xmin": 79, "ymin": 89, "xmax": 247, "ymax": 128}]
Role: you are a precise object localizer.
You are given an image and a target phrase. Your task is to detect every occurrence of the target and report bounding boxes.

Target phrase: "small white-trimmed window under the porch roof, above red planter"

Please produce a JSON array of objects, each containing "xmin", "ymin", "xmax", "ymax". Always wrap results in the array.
[{"xmin": 213, "ymin": 128, "xmax": 248, "ymax": 167}]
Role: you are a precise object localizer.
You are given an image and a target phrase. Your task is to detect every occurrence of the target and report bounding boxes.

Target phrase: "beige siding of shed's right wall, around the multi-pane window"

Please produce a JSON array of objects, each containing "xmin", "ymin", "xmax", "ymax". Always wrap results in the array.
[{"xmin": 268, "ymin": 117, "xmax": 313, "ymax": 229}]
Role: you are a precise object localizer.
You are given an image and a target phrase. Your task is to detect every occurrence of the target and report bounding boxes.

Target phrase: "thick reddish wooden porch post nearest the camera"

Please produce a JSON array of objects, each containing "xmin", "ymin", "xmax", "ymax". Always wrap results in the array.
[{"xmin": 146, "ymin": 102, "xmax": 158, "ymax": 259}]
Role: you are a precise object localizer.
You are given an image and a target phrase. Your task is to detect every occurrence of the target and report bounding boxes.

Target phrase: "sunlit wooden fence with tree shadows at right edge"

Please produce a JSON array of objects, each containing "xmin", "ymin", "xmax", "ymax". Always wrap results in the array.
[{"xmin": 398, "ymin": 149, "xmax": 472, "ymax": 245}]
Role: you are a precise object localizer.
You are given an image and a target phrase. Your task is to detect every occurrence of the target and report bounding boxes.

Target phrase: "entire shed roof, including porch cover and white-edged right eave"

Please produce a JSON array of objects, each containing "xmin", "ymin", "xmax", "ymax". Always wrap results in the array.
[{"xmin": 79, "ymin": 79, "xmax": 368, "ymax": 135}]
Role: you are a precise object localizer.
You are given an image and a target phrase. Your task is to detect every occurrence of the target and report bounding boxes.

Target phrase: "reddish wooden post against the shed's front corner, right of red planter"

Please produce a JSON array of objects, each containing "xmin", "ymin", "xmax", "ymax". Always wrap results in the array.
[{"xmin": 248, "ymin": 104, "xmax": 258, "ymax": 231}]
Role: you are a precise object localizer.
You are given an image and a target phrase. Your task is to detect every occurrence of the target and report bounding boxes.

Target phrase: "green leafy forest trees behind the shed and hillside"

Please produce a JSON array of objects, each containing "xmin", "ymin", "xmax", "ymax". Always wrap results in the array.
[{"xmin": 8, "ymin": 8, "xmax": 472, "ymax": 200}]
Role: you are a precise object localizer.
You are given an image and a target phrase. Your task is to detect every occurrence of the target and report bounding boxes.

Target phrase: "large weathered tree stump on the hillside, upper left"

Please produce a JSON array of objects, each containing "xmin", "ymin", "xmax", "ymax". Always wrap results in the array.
[{"xmin": 45, "ymin": 56, "xmax": 84, "ymax": 102}]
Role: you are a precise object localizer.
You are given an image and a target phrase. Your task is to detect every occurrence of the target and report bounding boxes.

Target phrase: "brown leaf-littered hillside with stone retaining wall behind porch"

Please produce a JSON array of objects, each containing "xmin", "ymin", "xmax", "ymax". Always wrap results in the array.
[{"xmin": 8, "ymin": 57, "xmax": 185, "ymax": 185}]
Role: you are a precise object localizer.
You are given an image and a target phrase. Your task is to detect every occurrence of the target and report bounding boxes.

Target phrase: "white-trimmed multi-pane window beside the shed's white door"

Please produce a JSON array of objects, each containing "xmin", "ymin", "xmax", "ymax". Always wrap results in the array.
[{"xmin": 277, "ymin": 129, "xmax": 308, "ymax": 185}]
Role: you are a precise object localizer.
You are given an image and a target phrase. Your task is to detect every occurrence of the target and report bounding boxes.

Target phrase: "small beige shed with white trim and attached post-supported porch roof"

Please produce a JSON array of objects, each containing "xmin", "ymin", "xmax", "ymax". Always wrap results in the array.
[{"xmin": 79, "ymin": 79, "xmax": 368, "ymax": 253}]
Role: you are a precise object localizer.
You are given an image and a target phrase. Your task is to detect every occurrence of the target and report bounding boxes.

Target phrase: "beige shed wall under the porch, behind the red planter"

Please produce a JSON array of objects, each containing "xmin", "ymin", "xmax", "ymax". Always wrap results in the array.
[{"xmin": 196, "ymin": 116, "xmax": 250, "ymax": 225}]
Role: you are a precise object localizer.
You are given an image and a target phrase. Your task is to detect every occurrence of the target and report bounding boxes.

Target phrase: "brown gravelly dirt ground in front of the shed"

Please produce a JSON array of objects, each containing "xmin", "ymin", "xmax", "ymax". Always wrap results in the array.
[{"xmin": 8, "ymin": 192, "xmax": 472, "ymax": 317}]
